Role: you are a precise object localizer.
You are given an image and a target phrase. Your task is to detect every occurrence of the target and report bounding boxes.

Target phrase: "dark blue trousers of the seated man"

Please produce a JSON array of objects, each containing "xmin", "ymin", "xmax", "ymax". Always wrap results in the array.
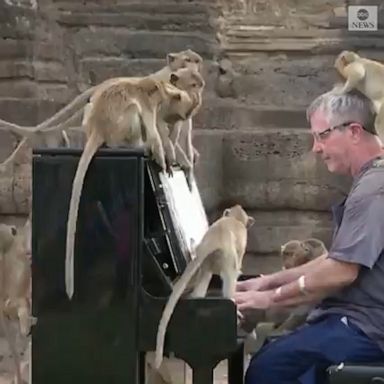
[{"xmin": 245, "ymin": 315, "xmax": 384, "ymax": 384}]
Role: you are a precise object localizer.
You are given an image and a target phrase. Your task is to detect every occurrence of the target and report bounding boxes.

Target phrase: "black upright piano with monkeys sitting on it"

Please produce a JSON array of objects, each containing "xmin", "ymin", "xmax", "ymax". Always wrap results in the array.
[{"xmin": 32, "ymin": 148, "xmax": 243, "ymax": 384}]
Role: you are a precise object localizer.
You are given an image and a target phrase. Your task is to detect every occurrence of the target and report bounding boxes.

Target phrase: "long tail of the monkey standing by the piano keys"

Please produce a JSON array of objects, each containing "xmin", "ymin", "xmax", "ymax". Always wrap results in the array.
[{"xmin": 155, "ymin": 249, "xmax": 208, "ymax": 369}]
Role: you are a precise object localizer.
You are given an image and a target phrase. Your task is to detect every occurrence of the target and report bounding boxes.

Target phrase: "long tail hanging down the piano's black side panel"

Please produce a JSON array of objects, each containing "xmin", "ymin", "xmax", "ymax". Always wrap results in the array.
[{"xmin": 65, "ymin": 133, "xmax": 103, "ymax": 299}]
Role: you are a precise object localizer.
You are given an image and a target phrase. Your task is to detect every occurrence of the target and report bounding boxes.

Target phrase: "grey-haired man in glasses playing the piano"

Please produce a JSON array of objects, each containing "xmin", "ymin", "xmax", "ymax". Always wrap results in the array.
[{"xmin": 235, "ymin": 88, "xmax": 384, "ymax": 384}]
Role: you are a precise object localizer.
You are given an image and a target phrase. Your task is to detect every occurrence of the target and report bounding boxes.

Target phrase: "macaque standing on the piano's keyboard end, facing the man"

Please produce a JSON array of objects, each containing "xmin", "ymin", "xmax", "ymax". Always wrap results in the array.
[{"xmin": 154, "ymin": 205, "xmax": 254, "ymax": 369}]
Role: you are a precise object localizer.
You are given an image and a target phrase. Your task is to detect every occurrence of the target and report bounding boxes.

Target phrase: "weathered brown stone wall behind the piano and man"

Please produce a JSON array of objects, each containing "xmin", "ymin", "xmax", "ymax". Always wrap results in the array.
[{"xmin": 0, "ymin": 0, "xmax": 384, "ymax": 272}]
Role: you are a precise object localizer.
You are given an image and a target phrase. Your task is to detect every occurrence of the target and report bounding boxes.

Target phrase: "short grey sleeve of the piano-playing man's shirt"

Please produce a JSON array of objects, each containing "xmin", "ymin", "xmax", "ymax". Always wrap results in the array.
[{"xmin": 328, "ymin": 193, "xmax": 384, "ymax": 268}]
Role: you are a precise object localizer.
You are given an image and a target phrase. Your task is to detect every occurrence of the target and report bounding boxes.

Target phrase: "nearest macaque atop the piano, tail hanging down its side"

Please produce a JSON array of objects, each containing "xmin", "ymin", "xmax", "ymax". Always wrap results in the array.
[{"xmin": 65, "ymin": 77, "xmax": 197, "ymax": 298}]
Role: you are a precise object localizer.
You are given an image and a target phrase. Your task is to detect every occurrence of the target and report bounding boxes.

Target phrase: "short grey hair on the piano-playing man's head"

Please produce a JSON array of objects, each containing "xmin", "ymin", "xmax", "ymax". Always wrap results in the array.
[{"xmin": 306, "ymin": 90, "xmax": 377, "ymax": 134}]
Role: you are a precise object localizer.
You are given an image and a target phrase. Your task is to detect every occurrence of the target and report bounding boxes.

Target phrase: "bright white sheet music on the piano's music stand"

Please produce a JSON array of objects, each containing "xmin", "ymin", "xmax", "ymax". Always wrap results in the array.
[{"xmin": 160, "ymin": 170, "xmax": 209, "ymax": 256}]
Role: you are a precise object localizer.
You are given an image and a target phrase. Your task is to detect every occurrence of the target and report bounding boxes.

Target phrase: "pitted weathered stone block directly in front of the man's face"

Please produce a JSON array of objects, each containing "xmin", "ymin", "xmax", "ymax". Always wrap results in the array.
[{"xmin": 222, "ymin": 130, "xmax": 348, "ymax": 211}]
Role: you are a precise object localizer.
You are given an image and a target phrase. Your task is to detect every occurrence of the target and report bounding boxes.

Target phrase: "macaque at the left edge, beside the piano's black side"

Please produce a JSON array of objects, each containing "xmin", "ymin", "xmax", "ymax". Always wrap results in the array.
[{"xmin": 0, "ymin": 224, "xmax": 34, "ymax": 384}]
